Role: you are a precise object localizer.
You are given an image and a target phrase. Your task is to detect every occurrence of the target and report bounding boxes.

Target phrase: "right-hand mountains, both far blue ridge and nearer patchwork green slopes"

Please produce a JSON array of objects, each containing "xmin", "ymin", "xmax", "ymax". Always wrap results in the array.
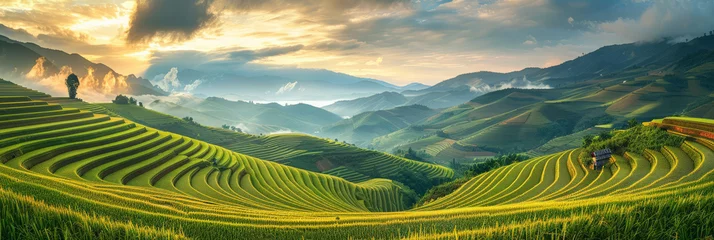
[{"xmin": 322, "ymin": 36, "xmax": 714, "ymax": 164}]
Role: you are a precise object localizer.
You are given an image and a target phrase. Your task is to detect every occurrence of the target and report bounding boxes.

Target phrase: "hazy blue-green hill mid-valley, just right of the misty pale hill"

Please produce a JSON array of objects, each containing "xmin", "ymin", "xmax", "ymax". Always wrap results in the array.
[{"xmin": 319, "ymin": 105, "xmax": 438, "ymax": 146}]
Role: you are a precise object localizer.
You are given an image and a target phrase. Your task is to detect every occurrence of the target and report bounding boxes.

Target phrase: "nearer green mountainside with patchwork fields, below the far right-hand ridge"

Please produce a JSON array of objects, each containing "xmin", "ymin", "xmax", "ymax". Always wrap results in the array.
[{"xmin": 372, "ymin": 39, "xmax": 714, "ymax": 163}]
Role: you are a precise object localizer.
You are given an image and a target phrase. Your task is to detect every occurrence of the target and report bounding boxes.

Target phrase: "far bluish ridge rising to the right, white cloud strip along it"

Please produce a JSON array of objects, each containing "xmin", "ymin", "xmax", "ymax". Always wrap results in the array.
[{"xmin": 325, "ymin": 36, "xmax": 714, "ymax": 118}]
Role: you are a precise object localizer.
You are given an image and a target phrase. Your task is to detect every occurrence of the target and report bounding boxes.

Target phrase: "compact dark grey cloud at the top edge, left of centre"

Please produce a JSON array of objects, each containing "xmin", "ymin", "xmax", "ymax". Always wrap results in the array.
[{"xmin": 126, "ymin": 0, "xmax": 217, "ymax": 43}]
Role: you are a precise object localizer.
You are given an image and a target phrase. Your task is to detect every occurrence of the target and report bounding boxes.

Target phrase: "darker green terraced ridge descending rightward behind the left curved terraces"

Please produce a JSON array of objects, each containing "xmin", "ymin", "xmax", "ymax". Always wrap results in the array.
[{"xmin": 34, "ymin": 90, "xmax": 454, "ymax": 192}]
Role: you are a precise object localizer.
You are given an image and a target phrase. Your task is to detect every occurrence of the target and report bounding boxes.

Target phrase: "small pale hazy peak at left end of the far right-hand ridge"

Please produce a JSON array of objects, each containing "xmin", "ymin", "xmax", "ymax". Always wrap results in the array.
[{"xmin": 323, "ymin": 92, "xmax": 408, "ymax": 116}]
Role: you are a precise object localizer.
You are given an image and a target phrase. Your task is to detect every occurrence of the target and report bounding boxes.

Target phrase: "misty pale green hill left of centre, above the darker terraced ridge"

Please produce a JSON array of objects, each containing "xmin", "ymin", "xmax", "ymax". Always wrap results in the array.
[{"xmin": 146, "ymin": 97, "xmax": 342, "ymax": 134}]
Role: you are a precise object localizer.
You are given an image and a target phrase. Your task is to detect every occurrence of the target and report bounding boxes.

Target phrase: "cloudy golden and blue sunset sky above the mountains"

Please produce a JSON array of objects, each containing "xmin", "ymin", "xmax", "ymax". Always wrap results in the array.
[{"xmin": 0, "ymin": 0, "xmax": 714, "ymax": 85}]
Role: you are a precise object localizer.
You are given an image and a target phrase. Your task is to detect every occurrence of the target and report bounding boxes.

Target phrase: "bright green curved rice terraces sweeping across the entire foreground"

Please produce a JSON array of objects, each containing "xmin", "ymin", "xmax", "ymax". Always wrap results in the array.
[{"xmin": 0, "ymin": 82, "xmax": 714, "ymax": 239}]
